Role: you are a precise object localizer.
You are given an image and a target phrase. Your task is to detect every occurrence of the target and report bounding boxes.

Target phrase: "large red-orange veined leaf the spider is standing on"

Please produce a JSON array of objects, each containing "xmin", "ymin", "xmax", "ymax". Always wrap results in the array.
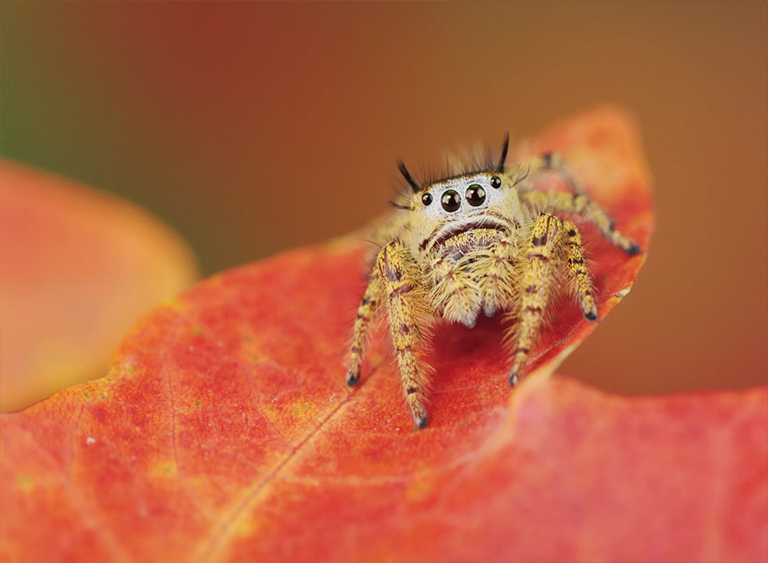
[{"xmin": 0, "ymin": 110, "xmax": 768, "ymax": 562}]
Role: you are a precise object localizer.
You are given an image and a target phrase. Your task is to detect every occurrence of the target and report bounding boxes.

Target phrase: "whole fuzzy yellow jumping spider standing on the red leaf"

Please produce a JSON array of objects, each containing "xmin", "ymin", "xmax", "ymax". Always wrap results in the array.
[{"xmin": 347, "ymin": 136, "xmax": 640, "ymax": 428}]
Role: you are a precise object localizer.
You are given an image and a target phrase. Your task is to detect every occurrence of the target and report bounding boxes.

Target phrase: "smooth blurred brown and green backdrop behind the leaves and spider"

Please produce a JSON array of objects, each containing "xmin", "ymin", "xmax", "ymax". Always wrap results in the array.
[{"xmin": 0, "ymin": 0, "xmax": 768, "ymax": 393}]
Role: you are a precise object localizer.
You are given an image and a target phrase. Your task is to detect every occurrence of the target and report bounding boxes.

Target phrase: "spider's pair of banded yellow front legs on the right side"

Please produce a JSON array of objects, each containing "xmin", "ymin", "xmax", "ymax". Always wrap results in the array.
[{"xmin": 509, "ymin": 213, "xmax": 597, "ymax": 385}]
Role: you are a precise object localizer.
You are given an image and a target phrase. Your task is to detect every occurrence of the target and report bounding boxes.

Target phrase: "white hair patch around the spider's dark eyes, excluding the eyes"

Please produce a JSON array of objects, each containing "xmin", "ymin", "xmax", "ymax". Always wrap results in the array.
[{"xmin": 422, "ymin": 174, "xmax": 503, "ymax": 219}]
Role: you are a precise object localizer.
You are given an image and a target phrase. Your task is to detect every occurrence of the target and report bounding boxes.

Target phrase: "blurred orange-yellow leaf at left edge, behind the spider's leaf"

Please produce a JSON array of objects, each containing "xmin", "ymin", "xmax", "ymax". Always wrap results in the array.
[{"xmin": 0, "ymin": 161, "xmax": 197, "ymax": 412}]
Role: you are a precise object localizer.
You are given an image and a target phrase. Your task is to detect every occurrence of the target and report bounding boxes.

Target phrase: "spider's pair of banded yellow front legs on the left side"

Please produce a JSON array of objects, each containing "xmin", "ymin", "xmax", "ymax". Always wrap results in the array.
[{"xmin": 347, "ymin": 241, "xmax": 428, "ymax": 428}]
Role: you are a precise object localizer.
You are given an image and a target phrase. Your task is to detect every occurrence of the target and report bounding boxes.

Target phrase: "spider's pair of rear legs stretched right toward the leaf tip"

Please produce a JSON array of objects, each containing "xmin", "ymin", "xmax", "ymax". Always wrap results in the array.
[{"xmin": 509, "ymin": 153, "xmax": 640, "ymax": 256}]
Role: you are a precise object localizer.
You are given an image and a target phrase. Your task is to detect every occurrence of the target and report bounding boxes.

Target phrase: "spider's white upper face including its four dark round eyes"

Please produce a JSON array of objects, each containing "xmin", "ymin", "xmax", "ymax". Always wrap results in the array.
[{"xmin": 413, "ymin": 171, "xmax": 512, "ymax": 237}]
